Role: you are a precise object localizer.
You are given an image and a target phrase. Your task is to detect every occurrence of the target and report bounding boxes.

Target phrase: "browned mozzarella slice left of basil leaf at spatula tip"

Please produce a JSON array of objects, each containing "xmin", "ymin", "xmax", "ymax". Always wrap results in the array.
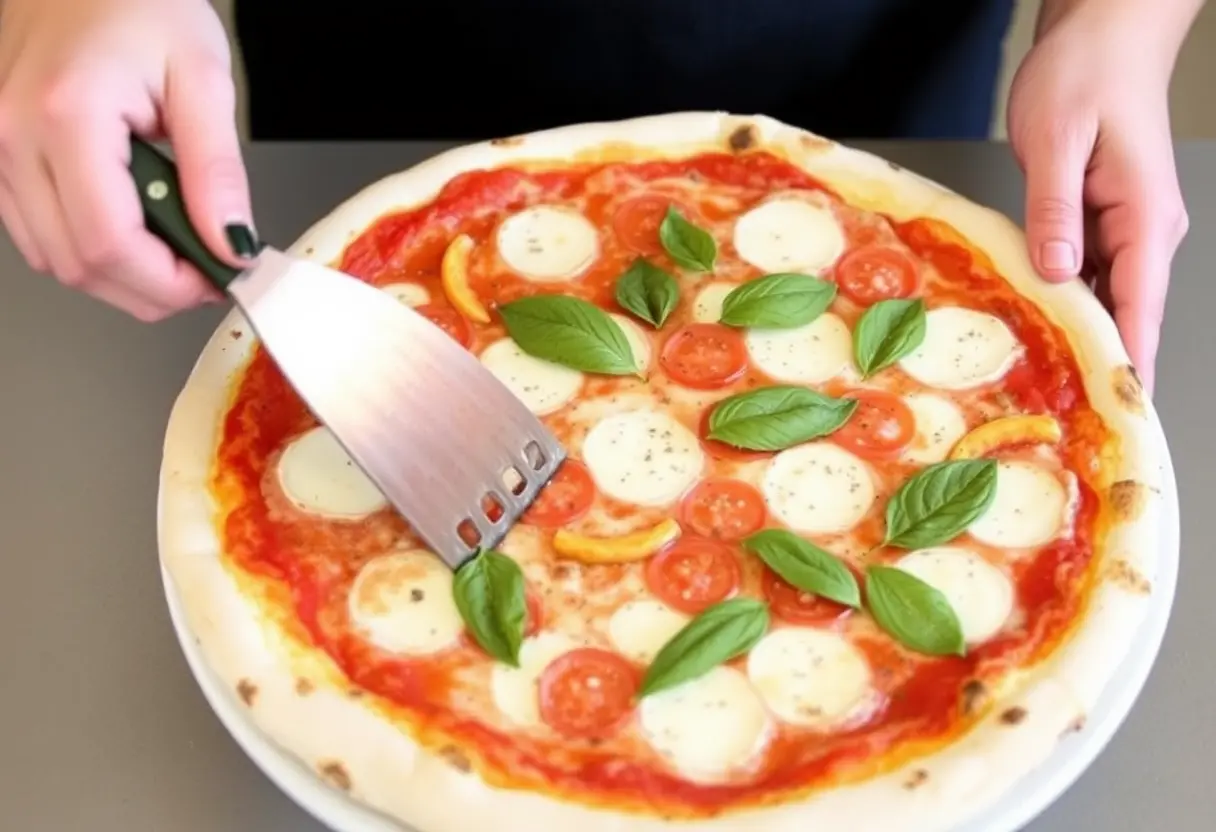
[{"xmin": 347, "ymin": 549, "xmax": 465, "ymax": 656}]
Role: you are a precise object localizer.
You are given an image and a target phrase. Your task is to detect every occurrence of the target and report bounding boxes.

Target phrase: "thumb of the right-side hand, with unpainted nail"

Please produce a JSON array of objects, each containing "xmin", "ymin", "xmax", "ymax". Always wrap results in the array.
[{"xmin": 1025, "ymin": 128, "xmax": 1092, "ymax": 282}]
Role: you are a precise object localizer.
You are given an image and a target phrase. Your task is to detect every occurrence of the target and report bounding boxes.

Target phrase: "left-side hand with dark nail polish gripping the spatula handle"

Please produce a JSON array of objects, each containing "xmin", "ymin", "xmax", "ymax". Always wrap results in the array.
[{"xmin": 0, "ymin": 0, "xmax": 253, "ymax": 321}]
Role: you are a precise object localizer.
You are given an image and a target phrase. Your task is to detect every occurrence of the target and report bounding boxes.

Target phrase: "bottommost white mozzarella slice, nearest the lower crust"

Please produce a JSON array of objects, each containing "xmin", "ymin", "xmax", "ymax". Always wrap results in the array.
[{"xmin": 638, "ymin": 667, "xmax": 772, "ymax": 782}]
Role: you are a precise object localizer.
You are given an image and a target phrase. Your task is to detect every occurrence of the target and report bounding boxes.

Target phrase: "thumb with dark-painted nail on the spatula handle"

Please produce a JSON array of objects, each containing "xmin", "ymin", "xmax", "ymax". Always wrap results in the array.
[{"xmin": 164, "ymin": 55, "xmax": 258, "ymax": 265}]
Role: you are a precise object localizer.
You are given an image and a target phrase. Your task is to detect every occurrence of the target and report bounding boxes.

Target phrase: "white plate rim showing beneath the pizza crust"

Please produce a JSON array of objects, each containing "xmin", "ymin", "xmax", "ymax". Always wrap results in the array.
[{"xmin": 161, "ymin": 415, "xmax": 1180, "ymax": 832}]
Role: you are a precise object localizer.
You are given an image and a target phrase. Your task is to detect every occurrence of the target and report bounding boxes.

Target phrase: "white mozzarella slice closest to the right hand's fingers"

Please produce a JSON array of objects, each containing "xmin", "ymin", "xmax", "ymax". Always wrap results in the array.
[{"xmin": 900, "ymin": 307, "xmax": 1021, "ymax": 390}]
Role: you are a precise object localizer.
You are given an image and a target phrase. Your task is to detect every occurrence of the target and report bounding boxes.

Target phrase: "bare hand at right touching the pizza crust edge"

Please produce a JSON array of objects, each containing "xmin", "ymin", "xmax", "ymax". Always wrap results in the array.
[{"xmin": 1009, "ymin": 2, "xmax": 1187, "ymax": 393}]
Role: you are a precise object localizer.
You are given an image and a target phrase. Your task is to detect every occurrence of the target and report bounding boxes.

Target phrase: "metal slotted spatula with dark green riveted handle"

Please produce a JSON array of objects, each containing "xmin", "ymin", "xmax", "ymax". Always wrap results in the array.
[{"xmin": 130, "ymin": 137, "xmax": 565, "ymax": 569}]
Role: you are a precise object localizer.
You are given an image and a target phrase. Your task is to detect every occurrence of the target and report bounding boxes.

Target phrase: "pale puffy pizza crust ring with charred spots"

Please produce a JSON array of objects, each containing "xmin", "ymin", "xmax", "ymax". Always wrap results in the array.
[{"xmin": 158, "ymin": 112, "xmax": 1165, "ymax": 832}]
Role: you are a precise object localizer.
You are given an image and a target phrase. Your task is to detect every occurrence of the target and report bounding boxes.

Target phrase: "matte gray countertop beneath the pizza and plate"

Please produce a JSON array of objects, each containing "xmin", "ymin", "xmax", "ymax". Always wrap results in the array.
[{"xmin": 0, "ymin": 144, "xmax": 1216, "ymax": 832}]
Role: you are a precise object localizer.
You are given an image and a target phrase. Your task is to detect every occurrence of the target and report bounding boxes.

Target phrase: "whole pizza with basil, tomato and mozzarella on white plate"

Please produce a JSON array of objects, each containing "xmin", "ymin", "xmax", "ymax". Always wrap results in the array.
[{"xmin": 161, "ymin": 113, "xmax": 1162, "ymax": 832}]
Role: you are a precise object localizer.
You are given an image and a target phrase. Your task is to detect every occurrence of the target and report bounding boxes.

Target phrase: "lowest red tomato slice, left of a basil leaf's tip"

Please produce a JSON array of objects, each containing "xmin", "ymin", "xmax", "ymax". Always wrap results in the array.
[{"xmin": 537, "ymin": 647, "xmax": 640, "ymax": 738}]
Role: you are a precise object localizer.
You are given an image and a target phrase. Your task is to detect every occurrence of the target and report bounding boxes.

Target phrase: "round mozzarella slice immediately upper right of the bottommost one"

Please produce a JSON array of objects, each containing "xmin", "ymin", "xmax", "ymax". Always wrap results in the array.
[{"xmin": 748, "ymin": 626, "xmax": 877, "ymax": 729}]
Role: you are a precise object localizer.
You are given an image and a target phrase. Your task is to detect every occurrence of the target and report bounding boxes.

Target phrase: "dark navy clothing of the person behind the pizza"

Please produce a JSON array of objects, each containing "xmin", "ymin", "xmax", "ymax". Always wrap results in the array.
[{"xmin": 236, "ymin": 0, "xmax": 1013, "ymax": 140}]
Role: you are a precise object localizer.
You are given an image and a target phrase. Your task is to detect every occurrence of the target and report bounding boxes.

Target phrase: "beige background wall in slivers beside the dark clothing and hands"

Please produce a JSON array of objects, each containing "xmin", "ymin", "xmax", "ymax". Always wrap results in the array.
[{"xmin": 214, "ymin": 0, "xmax": 1216, "ymax": 139}]
